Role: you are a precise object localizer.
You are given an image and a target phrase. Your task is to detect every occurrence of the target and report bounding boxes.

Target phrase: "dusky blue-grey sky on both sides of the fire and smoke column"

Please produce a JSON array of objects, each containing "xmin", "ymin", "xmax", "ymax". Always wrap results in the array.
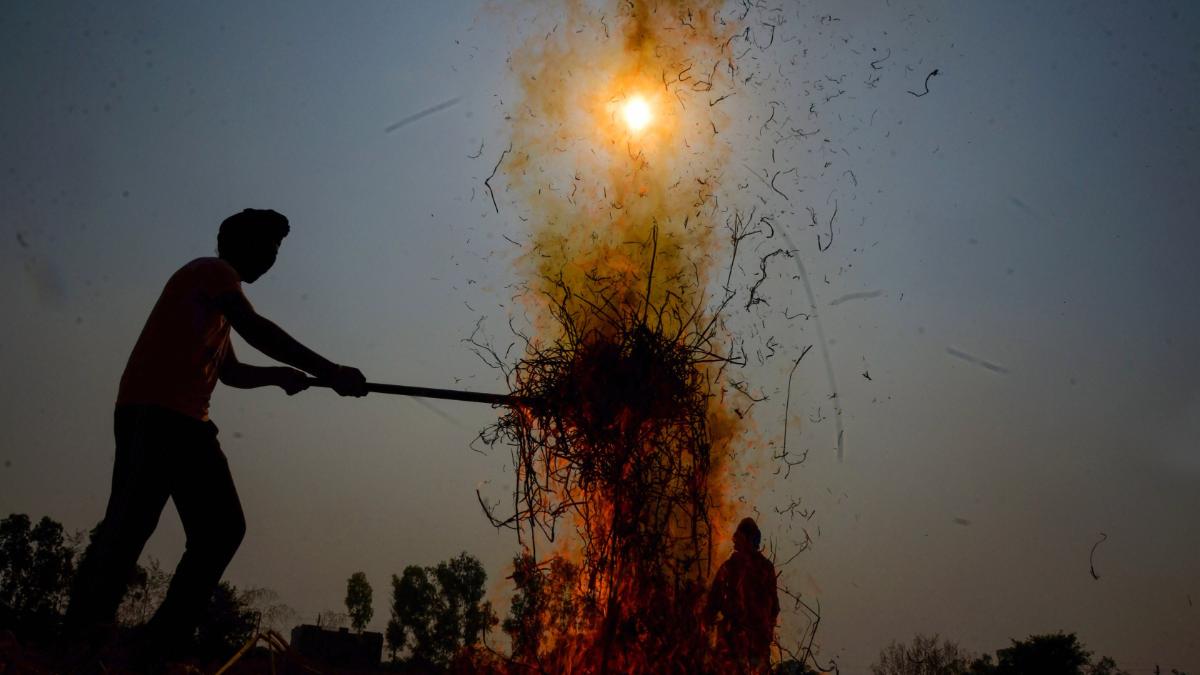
[{"xmin": 0, "ymin": 0, "xmax": 1200, "ymax": 674}]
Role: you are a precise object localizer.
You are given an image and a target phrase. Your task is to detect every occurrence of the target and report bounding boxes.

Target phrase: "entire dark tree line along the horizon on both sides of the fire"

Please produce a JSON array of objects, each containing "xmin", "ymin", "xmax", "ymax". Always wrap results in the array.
[{"xmin": 0, "ymin": 513, "xmax": 1187, "ymax": 675}]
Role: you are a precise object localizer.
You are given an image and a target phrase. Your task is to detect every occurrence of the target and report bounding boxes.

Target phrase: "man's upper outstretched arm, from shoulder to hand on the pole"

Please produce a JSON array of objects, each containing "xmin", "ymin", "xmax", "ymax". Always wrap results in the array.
[{"xmin": 216, "ymin": 291, "xmax": 367, "ymax": 396}]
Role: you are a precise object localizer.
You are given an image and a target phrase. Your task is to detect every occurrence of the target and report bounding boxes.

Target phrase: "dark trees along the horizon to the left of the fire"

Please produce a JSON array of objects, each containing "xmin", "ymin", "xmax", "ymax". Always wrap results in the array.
[{"xmin": 0, "ymin": 513, "xmax": 499, "ymax": 673}]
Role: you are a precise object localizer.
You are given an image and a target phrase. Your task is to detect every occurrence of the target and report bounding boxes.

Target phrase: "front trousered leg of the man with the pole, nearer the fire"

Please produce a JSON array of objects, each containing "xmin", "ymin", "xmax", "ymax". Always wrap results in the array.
[{"xmin": 150, "ymin": 420, "xmax": 246, "ymax": 649}]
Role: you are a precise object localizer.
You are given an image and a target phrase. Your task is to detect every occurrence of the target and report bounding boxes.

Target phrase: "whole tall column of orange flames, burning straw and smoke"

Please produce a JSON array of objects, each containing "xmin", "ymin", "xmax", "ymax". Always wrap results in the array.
[{"xmin": 472, "ymin": 0, "xmax": 772, "ymax": 674}]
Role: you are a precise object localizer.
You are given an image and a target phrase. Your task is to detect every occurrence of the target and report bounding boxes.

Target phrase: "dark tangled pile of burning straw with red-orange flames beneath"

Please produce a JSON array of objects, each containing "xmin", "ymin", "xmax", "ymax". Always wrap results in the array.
[{"xmin": 475, "ymin": 254, "xmax": 730, "ymax": 673}]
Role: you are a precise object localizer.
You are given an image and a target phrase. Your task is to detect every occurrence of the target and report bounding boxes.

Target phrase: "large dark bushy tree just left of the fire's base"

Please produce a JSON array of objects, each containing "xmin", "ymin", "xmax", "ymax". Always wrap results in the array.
[{"xmin": 386, "ymin": 551, "xmax": 497, "ymax": 668}]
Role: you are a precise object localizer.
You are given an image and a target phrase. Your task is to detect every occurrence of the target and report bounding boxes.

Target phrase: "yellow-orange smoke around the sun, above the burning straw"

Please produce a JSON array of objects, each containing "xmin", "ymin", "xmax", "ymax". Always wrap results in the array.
[{"xmin": 504, "ymin": 1, "xmax": 736, "ymax": 331}]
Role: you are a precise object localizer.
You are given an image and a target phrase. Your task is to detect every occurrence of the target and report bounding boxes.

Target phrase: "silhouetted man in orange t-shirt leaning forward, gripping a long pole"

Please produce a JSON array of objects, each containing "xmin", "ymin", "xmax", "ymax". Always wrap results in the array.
[{"xmin": 66, "ymin": 209, "xmax": 366, "ymax": 658}]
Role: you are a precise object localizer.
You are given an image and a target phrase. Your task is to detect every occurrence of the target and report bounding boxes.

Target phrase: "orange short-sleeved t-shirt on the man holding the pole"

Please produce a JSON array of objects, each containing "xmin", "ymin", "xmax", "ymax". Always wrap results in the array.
[{"xmin": 116, "ymin": 258, "xmax": 241, "ymax": 420}]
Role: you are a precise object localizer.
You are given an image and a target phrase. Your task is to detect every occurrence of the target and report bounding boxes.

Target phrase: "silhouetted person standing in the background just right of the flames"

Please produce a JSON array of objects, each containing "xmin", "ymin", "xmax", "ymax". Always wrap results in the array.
[{"xmin": 706, "ymin": 518, "xmax": 779, "ymax": 674}]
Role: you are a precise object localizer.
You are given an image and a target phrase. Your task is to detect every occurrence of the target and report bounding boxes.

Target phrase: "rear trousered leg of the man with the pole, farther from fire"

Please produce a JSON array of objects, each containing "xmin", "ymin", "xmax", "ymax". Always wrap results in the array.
[{"xmin": 66, "ymin": 406, "xmax": 170, "ymax": 638}]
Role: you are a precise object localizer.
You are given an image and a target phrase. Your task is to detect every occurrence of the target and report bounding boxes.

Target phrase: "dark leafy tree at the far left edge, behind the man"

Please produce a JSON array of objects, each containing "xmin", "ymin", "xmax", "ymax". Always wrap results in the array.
[{"xmin": 0, "ymin": 513, "xmax": 76, "ymax": 638}]
